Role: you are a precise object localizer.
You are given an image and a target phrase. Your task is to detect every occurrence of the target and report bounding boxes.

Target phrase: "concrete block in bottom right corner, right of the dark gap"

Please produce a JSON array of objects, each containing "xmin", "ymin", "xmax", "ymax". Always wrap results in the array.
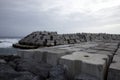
[{"xmin": 107, "ymin": 55, "xmax": 120, "ymax": 80}]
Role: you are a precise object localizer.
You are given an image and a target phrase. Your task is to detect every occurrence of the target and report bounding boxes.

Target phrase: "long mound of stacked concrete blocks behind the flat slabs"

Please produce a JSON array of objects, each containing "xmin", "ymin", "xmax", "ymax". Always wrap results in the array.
[{"xmin": 14, "ymin": 31, "xmax": 120, "ymax": 47}]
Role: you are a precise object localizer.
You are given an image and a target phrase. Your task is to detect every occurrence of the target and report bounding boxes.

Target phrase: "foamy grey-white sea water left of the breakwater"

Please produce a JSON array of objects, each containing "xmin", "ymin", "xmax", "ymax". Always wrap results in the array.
[{"xmin": 0, "ymin": 38, "xmax": 21, "ymax": 55}]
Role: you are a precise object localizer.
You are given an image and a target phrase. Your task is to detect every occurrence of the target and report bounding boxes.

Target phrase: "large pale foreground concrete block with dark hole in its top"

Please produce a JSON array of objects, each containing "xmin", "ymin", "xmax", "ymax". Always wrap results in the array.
[{"xmin": 60, "ymin": 52, "xmax": 109, "ymax": 80}]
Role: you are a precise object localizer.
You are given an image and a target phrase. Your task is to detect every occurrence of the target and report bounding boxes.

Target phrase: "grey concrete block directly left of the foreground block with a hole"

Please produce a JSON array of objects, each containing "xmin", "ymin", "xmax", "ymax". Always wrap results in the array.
[{"xmin": 18, "ymin": 48, "xmax": 71, "ymax": 65}]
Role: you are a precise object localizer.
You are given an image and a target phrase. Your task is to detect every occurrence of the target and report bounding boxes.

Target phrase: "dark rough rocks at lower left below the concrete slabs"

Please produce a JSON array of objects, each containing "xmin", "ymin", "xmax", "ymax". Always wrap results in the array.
[{"xmin": 0, "ymin": 55, "xmax": 67, "ymax": 80}]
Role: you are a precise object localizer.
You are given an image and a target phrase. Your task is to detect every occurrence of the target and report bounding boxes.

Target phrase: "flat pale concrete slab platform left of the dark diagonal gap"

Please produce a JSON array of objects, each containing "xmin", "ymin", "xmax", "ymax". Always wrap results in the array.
[{"xmin": 18, "ymin": 42, "xmax": 120, "ymax": 80}]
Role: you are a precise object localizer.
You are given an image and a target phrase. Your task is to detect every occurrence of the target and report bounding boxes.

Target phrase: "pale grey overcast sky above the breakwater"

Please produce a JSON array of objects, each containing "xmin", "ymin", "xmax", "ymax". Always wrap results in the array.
[{"xmin": 0, "ymin": 0, "xmax": 120, "ymax": 36}]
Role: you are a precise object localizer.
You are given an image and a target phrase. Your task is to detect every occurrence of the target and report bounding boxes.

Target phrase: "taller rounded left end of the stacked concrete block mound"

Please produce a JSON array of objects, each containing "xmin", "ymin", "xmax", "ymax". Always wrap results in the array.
[{"xmin": 19, "ymin": 31, "xmax": 57, "ymax": 46}]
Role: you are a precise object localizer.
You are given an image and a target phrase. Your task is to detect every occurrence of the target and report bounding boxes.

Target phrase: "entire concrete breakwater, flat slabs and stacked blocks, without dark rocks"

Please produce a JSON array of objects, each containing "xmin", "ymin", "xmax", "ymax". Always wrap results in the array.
[{"xmin": 13, "ymin": 31, "xmax": 120, "ymax": 80}]
